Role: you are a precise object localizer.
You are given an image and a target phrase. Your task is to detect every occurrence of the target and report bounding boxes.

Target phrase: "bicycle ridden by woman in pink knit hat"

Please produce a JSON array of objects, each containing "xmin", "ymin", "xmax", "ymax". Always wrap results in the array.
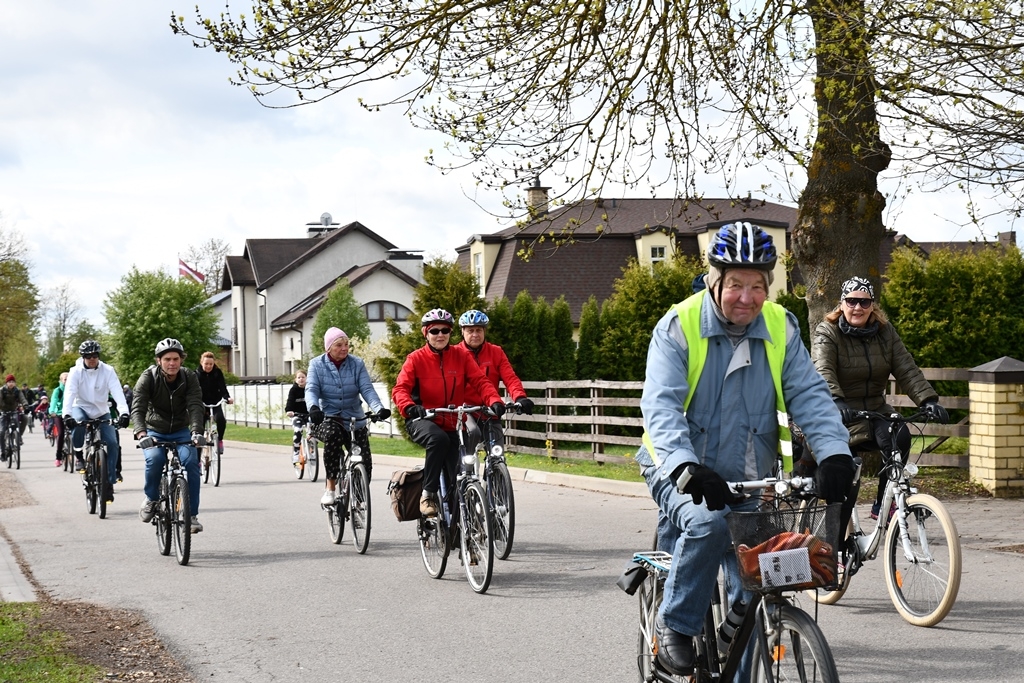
[{"xmin": 323, "ymin": 412, "xmax": 377, "ymax": 555}]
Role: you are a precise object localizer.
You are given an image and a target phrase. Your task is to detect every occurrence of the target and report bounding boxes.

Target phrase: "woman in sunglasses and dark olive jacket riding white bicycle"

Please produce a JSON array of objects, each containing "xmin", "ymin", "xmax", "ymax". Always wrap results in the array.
[{"xmin": 811, "ymin": 278, "xmax": 949, "ymax": 519}]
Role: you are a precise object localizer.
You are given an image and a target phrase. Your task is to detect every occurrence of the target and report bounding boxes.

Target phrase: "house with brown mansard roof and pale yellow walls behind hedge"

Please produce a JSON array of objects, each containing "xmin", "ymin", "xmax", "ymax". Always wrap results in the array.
[{"xmin": 456, "ymin": 185, "xmax": 797, "ymax": 325}]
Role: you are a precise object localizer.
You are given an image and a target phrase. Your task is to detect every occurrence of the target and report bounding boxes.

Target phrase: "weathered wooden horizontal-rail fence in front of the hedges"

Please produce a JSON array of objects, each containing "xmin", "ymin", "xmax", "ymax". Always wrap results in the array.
[{"xmin": 505, "ymin": 368, "xmax": 971, "ymax": 467}]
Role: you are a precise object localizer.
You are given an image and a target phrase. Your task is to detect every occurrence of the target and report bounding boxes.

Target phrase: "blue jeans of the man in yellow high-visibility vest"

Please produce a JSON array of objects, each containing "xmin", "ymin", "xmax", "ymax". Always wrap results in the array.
[{"xmin": 643, "ymin": 467, "xmax": 757, "ymax": 681}]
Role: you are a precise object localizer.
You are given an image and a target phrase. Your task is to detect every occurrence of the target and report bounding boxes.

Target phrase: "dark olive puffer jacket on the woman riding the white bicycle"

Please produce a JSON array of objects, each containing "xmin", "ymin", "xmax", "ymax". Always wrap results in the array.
[{"xmin": 811, "ymin": 321, "xmax": 938, "ymax": 445}]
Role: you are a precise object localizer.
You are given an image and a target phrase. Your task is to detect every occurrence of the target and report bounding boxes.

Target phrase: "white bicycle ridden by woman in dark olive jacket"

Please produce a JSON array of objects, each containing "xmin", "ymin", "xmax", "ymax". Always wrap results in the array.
[{"xmin": 812, "ymin": 411, "xmax": 963, "ymax": 627}]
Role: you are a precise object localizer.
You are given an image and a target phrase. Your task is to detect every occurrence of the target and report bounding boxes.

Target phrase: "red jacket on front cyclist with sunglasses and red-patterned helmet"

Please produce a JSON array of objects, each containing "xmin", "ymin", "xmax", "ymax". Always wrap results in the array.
[{"xmin": 391, "ymin": 344, "xmax": 501, "ymax": 431}]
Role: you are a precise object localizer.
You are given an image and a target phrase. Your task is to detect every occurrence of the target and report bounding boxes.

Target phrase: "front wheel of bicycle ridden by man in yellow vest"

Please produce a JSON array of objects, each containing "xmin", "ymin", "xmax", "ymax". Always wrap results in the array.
[{"xmin": 751, "ymin": 604, "xmax": 839, "ymax": 683}]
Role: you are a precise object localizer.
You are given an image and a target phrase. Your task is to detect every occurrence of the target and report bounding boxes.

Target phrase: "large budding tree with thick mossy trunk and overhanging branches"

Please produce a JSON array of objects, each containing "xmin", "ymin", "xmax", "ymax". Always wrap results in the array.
[{"xmin": 178, "ymin": 0, "xmax": 1024, "ymax": 319}]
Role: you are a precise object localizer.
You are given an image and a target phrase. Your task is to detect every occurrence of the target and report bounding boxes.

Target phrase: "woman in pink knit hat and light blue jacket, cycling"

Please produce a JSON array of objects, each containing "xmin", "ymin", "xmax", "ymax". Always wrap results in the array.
[{"xmin": 300, "ymin": 328, "xmax": 391, "ymax": 505}]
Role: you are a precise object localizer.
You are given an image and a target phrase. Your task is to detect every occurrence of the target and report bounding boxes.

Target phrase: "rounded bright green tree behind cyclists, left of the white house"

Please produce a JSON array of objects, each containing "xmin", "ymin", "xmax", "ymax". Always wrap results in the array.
[{"xmin": 103, "ymin": 266, "xmax": 218, "ymax": 384}]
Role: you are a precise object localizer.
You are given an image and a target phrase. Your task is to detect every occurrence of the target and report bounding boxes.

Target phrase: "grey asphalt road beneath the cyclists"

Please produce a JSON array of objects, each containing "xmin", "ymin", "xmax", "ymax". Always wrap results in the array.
[{"xmin": 0, "ymin": 434, "xmax": 1024, "ymax": 683}]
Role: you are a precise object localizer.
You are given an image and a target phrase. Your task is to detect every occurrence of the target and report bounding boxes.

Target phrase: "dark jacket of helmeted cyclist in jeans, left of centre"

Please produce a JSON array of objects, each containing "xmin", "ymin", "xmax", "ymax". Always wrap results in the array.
[{"xmin": 131, "ymin": 366, "xmax": 204, "ymax": 434}]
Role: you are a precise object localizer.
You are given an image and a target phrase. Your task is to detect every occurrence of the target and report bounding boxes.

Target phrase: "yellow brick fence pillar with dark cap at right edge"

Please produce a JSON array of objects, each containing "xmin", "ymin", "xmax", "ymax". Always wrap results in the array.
[{"xmin": 968, "ymin": 356, "xmax": 1024, "ymax": 498}]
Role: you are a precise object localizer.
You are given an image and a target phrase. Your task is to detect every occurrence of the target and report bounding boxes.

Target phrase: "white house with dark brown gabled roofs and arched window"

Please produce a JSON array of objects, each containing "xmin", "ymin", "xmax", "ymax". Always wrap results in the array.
[{"xmin": 221, "ymin": 213, "xmax": 423, "ymax": 377}]
